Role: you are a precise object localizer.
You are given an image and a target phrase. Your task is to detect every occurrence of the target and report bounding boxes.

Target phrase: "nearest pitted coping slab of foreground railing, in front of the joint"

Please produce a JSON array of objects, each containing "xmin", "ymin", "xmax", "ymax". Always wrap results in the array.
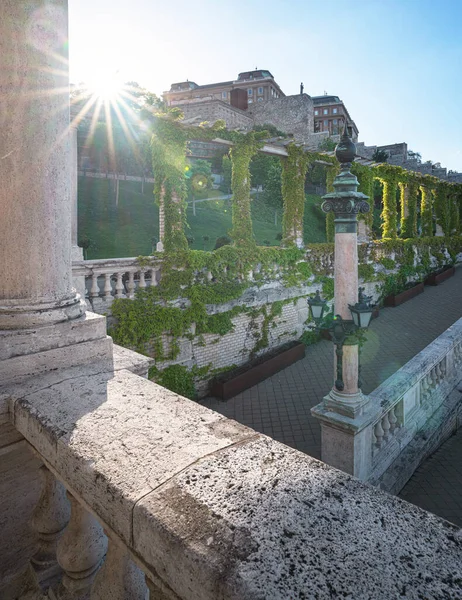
[{"xmin": 134, "ymin": 438, "xmax": 462, "ymax": 600}]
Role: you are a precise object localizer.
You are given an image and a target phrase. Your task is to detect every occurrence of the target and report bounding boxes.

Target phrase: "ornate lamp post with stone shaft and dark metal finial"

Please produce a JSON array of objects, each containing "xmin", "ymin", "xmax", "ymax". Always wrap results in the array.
[{"xmin": 312, "ymin": 125, "xmax": 372, "ymax": 418}]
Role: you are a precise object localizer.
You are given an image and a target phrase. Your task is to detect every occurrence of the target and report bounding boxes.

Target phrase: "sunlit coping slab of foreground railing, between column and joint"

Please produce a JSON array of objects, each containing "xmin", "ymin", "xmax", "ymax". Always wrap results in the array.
[{"xmin": 13, "ymin": 370, "xmax": 255, "ymax": 542}]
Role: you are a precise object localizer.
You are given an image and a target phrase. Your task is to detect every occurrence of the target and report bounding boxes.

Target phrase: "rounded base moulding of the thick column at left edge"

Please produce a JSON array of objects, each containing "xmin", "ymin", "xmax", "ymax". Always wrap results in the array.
[{"xmin": 0, "ymin": 290, "xmax": 85, "ymax": 330}]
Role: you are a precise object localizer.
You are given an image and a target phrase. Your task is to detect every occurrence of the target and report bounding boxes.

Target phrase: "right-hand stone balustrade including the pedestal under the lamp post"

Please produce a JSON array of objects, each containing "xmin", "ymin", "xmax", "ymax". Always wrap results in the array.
[{"xmin": 312, "ymin": 319, "xmax": 462, "ymax": 493}]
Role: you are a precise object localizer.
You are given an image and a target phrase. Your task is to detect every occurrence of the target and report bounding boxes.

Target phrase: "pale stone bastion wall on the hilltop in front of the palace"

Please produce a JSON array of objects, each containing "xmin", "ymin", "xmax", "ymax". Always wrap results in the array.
[{"xmin": 247, "ymin": 94, "xmax": 314, "ymax": 143}]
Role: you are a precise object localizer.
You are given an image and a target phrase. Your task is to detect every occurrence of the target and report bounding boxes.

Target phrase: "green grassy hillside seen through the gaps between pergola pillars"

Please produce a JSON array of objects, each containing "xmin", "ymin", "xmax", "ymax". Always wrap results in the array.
[{"xmin": 78, "ymin": 177, "xmax": 326, "ymax": 259}]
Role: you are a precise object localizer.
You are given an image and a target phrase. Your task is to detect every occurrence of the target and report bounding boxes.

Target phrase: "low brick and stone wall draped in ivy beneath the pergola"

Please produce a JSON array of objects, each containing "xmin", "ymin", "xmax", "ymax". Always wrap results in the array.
[{"xmin": 84, "ymin": 236, "xmax": 462, "ymax": 396}]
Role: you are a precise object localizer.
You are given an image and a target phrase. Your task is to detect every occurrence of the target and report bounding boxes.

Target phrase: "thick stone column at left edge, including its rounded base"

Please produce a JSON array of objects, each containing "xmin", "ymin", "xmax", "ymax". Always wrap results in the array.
[{"xmin": 0, "ymin": 0, "xmax": 84, "ymax": 330}]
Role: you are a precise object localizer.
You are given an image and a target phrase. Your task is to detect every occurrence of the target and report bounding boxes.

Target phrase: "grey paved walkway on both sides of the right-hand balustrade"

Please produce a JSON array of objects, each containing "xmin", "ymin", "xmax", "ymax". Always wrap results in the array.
[{"xmin": 202, "ymin": 267, "xmax": 462, "ymax": 527}]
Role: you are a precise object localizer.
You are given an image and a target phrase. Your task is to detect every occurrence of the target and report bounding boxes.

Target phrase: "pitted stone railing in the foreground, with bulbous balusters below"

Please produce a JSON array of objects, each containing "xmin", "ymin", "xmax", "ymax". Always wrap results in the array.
[{"xmin": 6, "ymin": 350, "xmax": 462, "ymax": 600}]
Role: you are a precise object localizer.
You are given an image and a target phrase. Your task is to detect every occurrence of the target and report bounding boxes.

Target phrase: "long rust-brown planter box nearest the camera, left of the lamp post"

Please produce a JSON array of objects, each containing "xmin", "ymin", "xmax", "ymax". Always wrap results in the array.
[{"xmin": 210, "ymin": 342, "xmax": 305, "ymax": 400}]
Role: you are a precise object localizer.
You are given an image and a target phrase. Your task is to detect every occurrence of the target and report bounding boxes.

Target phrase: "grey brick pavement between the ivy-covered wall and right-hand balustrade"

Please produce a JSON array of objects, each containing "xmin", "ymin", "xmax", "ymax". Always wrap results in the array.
[{"xmin": 201, "ymin": 267, "xmax": 462, "ymax": 458}]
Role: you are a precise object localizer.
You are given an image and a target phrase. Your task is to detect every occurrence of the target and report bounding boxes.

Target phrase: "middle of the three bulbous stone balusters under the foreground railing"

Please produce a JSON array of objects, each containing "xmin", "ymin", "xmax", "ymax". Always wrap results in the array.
[{"xmin": 56, "ymin": 493, "xmax": 107, "ymax": 597}]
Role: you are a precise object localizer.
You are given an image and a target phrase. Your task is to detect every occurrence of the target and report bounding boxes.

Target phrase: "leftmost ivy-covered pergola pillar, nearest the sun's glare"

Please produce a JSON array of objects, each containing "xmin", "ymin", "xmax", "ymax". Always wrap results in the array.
[{"xmin": 151, "ymin": 117, "xmax": 188, "ymax": 252}]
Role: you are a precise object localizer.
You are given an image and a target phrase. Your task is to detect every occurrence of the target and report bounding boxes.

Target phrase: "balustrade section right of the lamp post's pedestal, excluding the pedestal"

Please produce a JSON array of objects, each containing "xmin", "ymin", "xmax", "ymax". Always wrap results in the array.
[{"xmin": 368, "ymin": 319, "xmax": 462, "ymax": 491}]
